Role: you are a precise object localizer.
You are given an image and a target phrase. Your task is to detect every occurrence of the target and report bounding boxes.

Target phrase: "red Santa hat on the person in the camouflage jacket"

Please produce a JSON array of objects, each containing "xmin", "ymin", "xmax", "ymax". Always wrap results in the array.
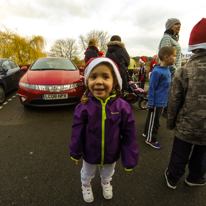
[{"xmin": 188, "ymin": 18, "xmax": 206, "ymax": 51}]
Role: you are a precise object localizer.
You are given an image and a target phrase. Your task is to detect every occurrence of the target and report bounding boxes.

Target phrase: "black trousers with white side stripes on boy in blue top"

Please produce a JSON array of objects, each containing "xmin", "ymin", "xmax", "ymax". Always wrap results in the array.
[{"xmin": 144, "ymin": 107, "xmax": 162, "ymax": 142}]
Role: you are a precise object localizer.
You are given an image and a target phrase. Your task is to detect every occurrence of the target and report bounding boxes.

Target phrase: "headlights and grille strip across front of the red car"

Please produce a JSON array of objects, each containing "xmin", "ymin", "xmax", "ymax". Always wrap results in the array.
[{"xmin": 19, "ymin": 82, "xmax": 84, "ymax": 92}]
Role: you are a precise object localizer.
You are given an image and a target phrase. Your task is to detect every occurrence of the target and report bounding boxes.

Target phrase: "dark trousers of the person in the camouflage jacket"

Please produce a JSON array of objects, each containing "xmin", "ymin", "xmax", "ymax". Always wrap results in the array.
[{"xmin": 168, "ymin": 137, "xmax": 206, "ymax": 183}]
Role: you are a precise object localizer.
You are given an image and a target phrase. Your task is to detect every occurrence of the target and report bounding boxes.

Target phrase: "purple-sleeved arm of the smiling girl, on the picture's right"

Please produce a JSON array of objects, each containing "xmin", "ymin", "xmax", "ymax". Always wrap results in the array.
[{"xmin": 121, "ymin": 104, "xmax": 139, "ymax": 171}]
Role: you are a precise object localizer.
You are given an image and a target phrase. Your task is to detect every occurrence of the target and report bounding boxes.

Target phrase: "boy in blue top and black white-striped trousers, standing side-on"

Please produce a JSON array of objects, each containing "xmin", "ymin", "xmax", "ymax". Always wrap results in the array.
[{"xmin": 142, "ymin": 46, "xmax": 176, "ymax": 149}]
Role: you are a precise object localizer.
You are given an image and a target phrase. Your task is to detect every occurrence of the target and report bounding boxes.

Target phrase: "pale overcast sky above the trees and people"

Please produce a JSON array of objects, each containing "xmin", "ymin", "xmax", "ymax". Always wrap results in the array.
[{"xmin": 0, "ymin": 0, "xmax": 206, "ymax": 57}]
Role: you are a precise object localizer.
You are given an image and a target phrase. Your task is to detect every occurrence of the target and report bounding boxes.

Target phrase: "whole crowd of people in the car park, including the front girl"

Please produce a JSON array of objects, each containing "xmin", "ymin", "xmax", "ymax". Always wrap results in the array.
[{"xmin": 69, "ymin": 18, "xmax": 206, "ymax": 202}]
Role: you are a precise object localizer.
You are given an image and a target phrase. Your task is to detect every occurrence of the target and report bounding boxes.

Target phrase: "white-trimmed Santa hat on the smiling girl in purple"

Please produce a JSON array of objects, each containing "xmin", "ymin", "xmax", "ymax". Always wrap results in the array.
[{"xmin": 84, "ymin": 57, "xmax": 122, "ymax": 89}]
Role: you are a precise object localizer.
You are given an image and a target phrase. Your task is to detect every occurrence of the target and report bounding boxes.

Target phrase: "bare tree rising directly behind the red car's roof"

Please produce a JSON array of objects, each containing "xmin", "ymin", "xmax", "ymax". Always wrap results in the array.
[{"xmin": 49, "ymin": 38, "xmax": 79, "ymax": 60}]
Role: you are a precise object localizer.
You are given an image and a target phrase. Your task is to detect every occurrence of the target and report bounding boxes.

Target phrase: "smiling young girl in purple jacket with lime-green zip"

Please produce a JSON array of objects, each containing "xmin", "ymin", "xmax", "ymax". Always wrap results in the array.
[{"xmin": 69, "ymin": 57, "xmax": 139, "ymax": 202}]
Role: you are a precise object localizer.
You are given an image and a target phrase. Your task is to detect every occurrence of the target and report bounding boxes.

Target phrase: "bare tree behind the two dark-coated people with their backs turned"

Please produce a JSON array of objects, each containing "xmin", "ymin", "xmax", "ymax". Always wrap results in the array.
[{"xmin": 79, "ymin": 30, "xmax": 110, "ymax": 53}]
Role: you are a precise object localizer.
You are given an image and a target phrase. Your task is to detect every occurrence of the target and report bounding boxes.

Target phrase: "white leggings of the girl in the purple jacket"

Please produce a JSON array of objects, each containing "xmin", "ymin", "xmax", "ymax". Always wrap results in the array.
[{"xmin": 81, "ymin": 160, "xmax": 116, "ymax": 185}]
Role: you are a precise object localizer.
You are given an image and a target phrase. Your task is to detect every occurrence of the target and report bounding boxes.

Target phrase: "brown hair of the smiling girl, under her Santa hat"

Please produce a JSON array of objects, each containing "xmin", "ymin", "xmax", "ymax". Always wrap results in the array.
[{"xmin": 81, "ymin": 62, "xmax": 122, "ymax": 104}]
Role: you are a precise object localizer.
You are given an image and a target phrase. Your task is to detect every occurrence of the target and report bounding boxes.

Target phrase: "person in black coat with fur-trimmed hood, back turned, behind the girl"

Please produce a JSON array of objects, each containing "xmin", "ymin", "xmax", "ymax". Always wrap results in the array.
[{"xmin": 106, "ymin": 35, "xmax": 130, "ymax": 96}]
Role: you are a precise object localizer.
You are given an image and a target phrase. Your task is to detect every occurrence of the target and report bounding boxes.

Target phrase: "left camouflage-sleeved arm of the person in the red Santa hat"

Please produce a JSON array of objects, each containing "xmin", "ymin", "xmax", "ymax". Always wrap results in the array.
[{"xmin": 167, "ymin": 69, "xmax": 184, "ymax": 130}]
